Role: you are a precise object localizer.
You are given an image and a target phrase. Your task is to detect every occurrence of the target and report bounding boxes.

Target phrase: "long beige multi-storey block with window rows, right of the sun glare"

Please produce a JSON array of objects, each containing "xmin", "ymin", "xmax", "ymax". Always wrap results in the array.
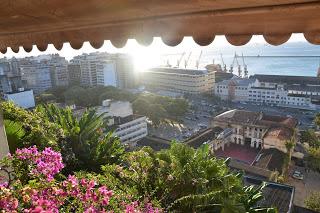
[{"xmin": 141, "ymin": 67, "xmax": 218, "ymax": 94}]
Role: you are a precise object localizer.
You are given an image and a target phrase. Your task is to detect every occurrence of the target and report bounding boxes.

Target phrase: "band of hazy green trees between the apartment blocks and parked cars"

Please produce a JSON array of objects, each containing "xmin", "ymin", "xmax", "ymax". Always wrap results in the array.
[{"xmin": 37, "ymin": 86, "xmax": 189, "ymax": 127}]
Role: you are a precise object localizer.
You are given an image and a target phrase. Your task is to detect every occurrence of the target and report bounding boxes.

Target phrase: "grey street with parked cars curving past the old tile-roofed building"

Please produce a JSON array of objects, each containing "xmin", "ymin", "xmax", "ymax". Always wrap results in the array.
[{"xmin": 149, "ymin": 96, "xmax": 317, "ymax": 141}]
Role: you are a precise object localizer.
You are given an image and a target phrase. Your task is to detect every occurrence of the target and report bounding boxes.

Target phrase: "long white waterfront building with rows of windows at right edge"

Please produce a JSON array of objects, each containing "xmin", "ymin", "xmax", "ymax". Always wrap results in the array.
[{"xmin": 215, "ymin": 76, "xmax": 320, "ymax": 110}]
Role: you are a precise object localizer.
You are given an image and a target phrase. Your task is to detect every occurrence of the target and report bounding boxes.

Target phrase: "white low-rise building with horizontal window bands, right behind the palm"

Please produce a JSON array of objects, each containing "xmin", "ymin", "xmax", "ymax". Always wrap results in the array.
[{"xmin": 97, "ymin": 100, "xmax": 148, "ymax": 147}]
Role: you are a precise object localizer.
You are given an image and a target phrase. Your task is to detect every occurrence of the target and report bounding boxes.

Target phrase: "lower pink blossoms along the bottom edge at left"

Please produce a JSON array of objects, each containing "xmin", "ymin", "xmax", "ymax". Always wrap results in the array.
[{"xmin": 0, "ymin": 176, "xmax": 159, "ymax": 213}]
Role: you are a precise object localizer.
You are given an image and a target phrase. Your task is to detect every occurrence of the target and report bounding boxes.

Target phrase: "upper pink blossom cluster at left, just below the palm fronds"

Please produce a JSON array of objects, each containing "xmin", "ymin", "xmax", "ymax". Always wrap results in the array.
[{"xmin": 15, "ymin": 146, "xmax": 64, "ymax": 181}]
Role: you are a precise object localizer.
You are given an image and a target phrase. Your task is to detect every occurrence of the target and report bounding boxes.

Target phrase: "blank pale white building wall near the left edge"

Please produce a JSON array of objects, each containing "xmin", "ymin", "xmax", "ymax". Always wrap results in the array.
[{"xmin": 4, "ymin": 90, "xmax": 35, "ymax": 109}]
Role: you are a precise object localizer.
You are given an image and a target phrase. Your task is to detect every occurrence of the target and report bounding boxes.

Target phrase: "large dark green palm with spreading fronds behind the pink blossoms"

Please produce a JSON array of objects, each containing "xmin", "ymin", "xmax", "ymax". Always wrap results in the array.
[{"xmin": 37, "ymin": 104, "xmax": 124, "ymax": 171}]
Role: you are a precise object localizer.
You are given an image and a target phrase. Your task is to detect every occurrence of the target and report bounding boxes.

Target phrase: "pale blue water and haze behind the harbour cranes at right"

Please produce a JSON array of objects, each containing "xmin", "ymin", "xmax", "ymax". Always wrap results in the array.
[{"xmin": 200, "ymin": 42, "xmax": 320, "ymax": 76}]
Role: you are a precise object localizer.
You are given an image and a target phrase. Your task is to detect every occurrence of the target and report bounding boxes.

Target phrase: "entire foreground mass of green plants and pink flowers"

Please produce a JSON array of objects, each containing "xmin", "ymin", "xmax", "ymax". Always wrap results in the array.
[{"xmin": 0, "ymin": 102, "xmax": 275, "ymax": 213}]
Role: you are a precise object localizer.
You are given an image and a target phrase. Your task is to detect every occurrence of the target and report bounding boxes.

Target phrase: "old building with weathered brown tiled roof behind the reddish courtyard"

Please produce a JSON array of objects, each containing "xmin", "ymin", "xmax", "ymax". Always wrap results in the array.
[{"xmin": 211, "ymin": 110, "xmax": 298, "ymax": 152}]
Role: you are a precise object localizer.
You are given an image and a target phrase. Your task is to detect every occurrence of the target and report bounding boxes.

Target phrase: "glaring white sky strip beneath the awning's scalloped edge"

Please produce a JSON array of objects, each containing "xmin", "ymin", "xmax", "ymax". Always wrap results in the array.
[{"xmin": 0, "ymin": 34, "xmax": 306, "ymax": 69}]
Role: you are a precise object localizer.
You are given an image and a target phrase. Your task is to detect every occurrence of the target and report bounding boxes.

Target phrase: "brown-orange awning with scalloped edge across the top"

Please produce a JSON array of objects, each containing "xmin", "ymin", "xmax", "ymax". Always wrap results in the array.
[{"xmin": 0, "ymin": 0, "xmax": 320, "ymax": 53}]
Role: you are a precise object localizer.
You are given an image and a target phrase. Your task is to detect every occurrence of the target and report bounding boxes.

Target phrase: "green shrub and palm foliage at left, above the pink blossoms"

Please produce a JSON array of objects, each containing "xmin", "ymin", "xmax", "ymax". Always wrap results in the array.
[{"xmin": 1, "ymin": 102, "xmax": 124, "ymax": 174}]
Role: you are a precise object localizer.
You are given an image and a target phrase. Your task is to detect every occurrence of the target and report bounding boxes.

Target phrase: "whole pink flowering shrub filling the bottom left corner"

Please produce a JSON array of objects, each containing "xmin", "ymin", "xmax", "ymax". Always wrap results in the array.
[{"xmin": 0, "ymin": 146, "xmax": 159, "ymax": 213}]
